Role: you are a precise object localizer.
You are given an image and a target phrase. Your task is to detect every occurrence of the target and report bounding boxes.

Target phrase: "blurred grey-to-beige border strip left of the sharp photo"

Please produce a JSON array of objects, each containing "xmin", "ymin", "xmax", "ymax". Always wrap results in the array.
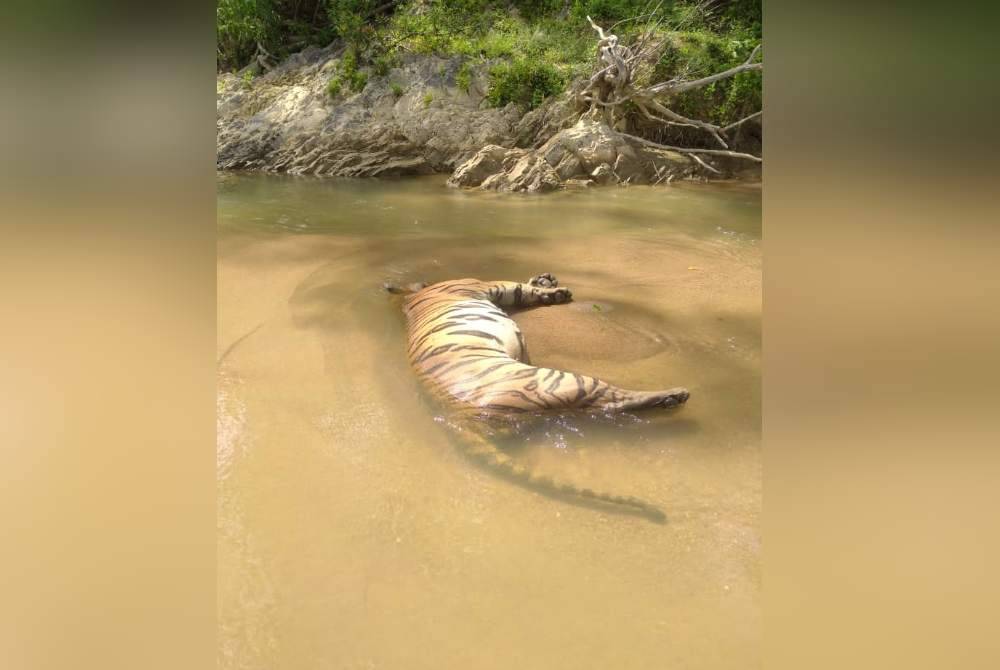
[{"xmin": 0, "ymin": 3, "xmax": 215, "ymax": 670}]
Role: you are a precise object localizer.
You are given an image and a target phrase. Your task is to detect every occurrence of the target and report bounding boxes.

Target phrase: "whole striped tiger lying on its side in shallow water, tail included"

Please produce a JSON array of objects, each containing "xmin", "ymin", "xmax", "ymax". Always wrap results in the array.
[{"xmin": 384, "ymin": 273, "xmax": 690, "ymax": 522}]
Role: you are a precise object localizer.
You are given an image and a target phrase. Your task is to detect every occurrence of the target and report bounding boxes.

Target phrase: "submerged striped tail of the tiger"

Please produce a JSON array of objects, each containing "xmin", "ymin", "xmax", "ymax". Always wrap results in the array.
[{"xmin": 461, "ymin": 431, "xmax": 667, "ymax": 523}]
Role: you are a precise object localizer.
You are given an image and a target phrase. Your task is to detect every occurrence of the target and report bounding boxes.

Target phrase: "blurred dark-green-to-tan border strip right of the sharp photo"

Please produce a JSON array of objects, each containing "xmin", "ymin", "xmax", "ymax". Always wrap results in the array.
[{"xmin": 764, "ymin": 3, "xmax": 1000, "ymax": 669}]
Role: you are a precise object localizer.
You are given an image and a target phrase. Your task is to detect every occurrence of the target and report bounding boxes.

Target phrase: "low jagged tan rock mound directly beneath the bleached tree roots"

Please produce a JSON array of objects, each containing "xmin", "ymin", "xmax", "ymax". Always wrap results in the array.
[{"xmin": 448, "ymin": 118, "xmax": 696, "ymax": 192}]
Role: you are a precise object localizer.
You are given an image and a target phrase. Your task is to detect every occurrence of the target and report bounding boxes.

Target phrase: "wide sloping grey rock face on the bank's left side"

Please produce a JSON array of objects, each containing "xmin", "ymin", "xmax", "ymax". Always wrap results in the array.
[{"xmin": 216, "ymin": 48, "xmax": 522, "ymax": 177}]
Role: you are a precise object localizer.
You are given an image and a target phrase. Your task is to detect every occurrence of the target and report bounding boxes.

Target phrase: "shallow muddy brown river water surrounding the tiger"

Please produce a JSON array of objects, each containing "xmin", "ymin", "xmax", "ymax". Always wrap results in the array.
[{"xmin": 217, "ymin": 174, "xmax": 761, "ymax": 670}]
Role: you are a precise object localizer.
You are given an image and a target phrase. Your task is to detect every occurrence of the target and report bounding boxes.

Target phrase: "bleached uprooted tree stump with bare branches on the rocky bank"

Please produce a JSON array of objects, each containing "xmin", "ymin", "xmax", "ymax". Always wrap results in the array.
[{"xmin": 579, "ymin": 10, "xmax": 764, "ymax": 174}]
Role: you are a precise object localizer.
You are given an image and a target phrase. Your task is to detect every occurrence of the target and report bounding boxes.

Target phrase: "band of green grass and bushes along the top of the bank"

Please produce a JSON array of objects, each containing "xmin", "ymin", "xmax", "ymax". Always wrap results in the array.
[{"xmin": 216, "ymin": 0, "xmax": 761, "ymax": 123}]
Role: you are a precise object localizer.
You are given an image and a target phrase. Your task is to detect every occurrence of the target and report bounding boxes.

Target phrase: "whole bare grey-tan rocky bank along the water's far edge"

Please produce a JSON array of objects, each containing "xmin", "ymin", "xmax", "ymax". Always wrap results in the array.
[{"xmin": 216, "ymin": 46, "xmax": 752, "ymax": 192}]
